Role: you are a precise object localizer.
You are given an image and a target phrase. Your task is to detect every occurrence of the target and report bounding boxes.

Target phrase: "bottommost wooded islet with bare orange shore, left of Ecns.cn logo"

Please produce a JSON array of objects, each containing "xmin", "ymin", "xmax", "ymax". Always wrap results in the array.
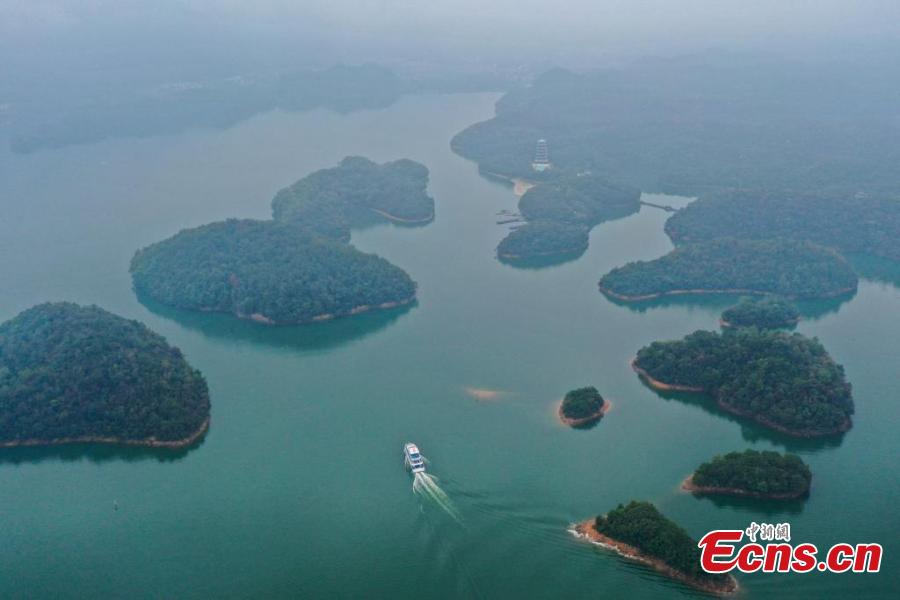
[{"xmin": 575, "ymin": 500, "xmax": 737, "ymax": 595}]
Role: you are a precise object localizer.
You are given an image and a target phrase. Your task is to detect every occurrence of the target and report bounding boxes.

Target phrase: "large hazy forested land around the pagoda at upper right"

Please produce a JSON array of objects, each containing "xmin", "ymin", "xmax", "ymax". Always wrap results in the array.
[{"xmin": 452, "ymin": 60, "xmax": 900, "ymax": 195}]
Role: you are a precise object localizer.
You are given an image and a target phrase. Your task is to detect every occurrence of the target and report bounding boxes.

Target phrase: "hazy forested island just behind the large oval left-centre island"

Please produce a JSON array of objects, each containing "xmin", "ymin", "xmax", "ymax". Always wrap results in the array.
[{"xmin": 272, "ymin": 156, "xmax": 434, "ymax": 240}]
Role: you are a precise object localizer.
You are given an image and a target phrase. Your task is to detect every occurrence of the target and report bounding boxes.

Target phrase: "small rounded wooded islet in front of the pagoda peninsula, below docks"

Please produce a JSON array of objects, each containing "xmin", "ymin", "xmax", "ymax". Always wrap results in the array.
[{"xmin": 497, "ymin": 221, "xmax": 588, "ymax": 261}]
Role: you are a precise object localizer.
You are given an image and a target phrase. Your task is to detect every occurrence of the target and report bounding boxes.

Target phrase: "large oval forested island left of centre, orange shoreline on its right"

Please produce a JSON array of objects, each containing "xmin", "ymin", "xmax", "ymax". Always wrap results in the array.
[{"xmin": 131, "ymin": 219, "xmax": 416, "ymax": 324}]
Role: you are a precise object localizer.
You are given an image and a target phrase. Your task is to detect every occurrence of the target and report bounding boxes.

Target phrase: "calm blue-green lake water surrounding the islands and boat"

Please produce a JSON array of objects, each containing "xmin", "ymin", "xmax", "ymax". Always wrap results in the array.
[{"xmin": 0, "ymin": 95, "xmax": 900, "ymax": 598}]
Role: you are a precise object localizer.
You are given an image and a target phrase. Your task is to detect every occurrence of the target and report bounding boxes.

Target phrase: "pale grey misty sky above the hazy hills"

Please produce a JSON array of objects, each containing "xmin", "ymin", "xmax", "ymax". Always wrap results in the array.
[{"xmin": 0, "ymin": 0, "xmax": 900, "ymax": 99}]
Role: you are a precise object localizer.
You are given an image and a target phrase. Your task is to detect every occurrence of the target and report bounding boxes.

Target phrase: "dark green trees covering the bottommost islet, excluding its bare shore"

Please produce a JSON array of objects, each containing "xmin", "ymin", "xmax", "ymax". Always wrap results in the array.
[{"xmin": 594, "ymin": 500, "xmax": 727, "ymax": 585}]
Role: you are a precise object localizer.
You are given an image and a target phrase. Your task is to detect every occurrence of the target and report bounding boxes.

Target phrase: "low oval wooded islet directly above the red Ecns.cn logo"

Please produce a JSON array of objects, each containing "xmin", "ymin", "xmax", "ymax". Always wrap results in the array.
[{"xmin": 681, "ymin": 450, "xmax": 812, "ymax": 500}]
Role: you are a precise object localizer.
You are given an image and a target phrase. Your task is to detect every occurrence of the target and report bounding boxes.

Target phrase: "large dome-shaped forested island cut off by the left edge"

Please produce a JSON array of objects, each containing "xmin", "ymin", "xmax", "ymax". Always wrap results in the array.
[{"xmin": 0, "ymin": 302, "xmax": 209, "ymax": 447}]
